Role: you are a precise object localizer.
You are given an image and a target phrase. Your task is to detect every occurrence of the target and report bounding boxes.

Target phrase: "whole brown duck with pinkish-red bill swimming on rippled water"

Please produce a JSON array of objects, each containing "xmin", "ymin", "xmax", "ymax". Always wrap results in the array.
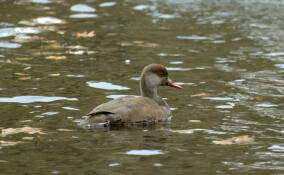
[{"xmin": 83, "ymin": 64, "xmax": 182, "ymax": 126}]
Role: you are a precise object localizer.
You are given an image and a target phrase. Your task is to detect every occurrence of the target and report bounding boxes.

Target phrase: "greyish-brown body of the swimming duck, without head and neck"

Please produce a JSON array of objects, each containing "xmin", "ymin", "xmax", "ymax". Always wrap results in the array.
[{"xmin": 85, "ymin": 96, "xmax": 171, "ymax": 124}]
